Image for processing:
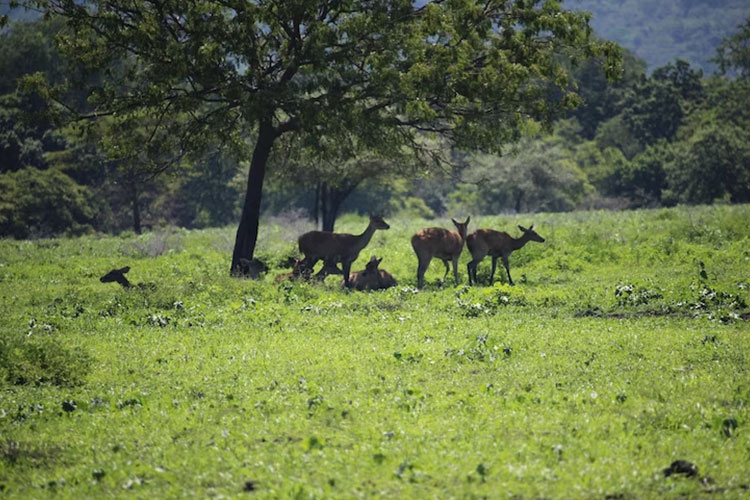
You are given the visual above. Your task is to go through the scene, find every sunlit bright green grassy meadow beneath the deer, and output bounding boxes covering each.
[0,205,750,499]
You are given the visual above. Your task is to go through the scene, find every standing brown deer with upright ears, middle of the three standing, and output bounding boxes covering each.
[411,217,471,288]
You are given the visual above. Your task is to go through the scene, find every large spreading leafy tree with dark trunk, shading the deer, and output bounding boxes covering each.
[20,0,619,272]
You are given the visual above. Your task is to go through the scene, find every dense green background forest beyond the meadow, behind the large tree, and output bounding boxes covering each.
[0,2,750,243]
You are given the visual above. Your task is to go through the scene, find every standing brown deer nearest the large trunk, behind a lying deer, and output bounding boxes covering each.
[297,215,391,285]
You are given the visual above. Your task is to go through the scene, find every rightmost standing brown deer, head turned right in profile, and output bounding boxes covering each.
[466,224,544,285]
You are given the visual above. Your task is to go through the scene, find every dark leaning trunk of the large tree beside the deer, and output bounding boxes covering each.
[230,121,277,276]
